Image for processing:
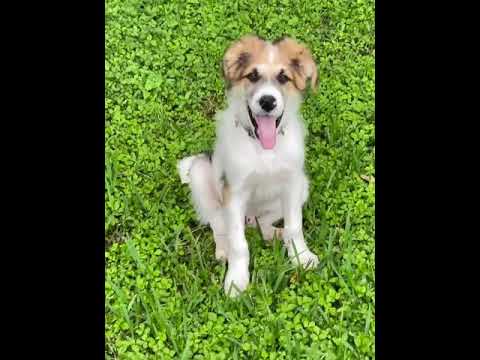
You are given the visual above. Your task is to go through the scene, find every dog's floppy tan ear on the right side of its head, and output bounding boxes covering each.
[275,38,317,90]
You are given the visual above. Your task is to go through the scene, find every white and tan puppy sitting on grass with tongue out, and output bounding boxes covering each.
[177,35,319,297]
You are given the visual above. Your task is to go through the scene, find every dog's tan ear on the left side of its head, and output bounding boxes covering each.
[223,35,265,82]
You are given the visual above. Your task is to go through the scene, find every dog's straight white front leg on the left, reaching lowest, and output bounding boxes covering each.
[224,191,250,297]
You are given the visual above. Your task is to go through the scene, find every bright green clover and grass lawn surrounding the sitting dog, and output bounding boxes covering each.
[105,0,375,360]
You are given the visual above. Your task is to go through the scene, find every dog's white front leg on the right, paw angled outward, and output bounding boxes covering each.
[282,176,318,268]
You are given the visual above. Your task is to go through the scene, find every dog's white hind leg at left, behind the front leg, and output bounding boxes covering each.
[177,154,228,260]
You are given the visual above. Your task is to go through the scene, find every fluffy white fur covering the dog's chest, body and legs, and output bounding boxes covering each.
[178,44,318,296]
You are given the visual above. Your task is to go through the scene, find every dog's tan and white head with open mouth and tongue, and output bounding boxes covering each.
[223,36,317,149]
